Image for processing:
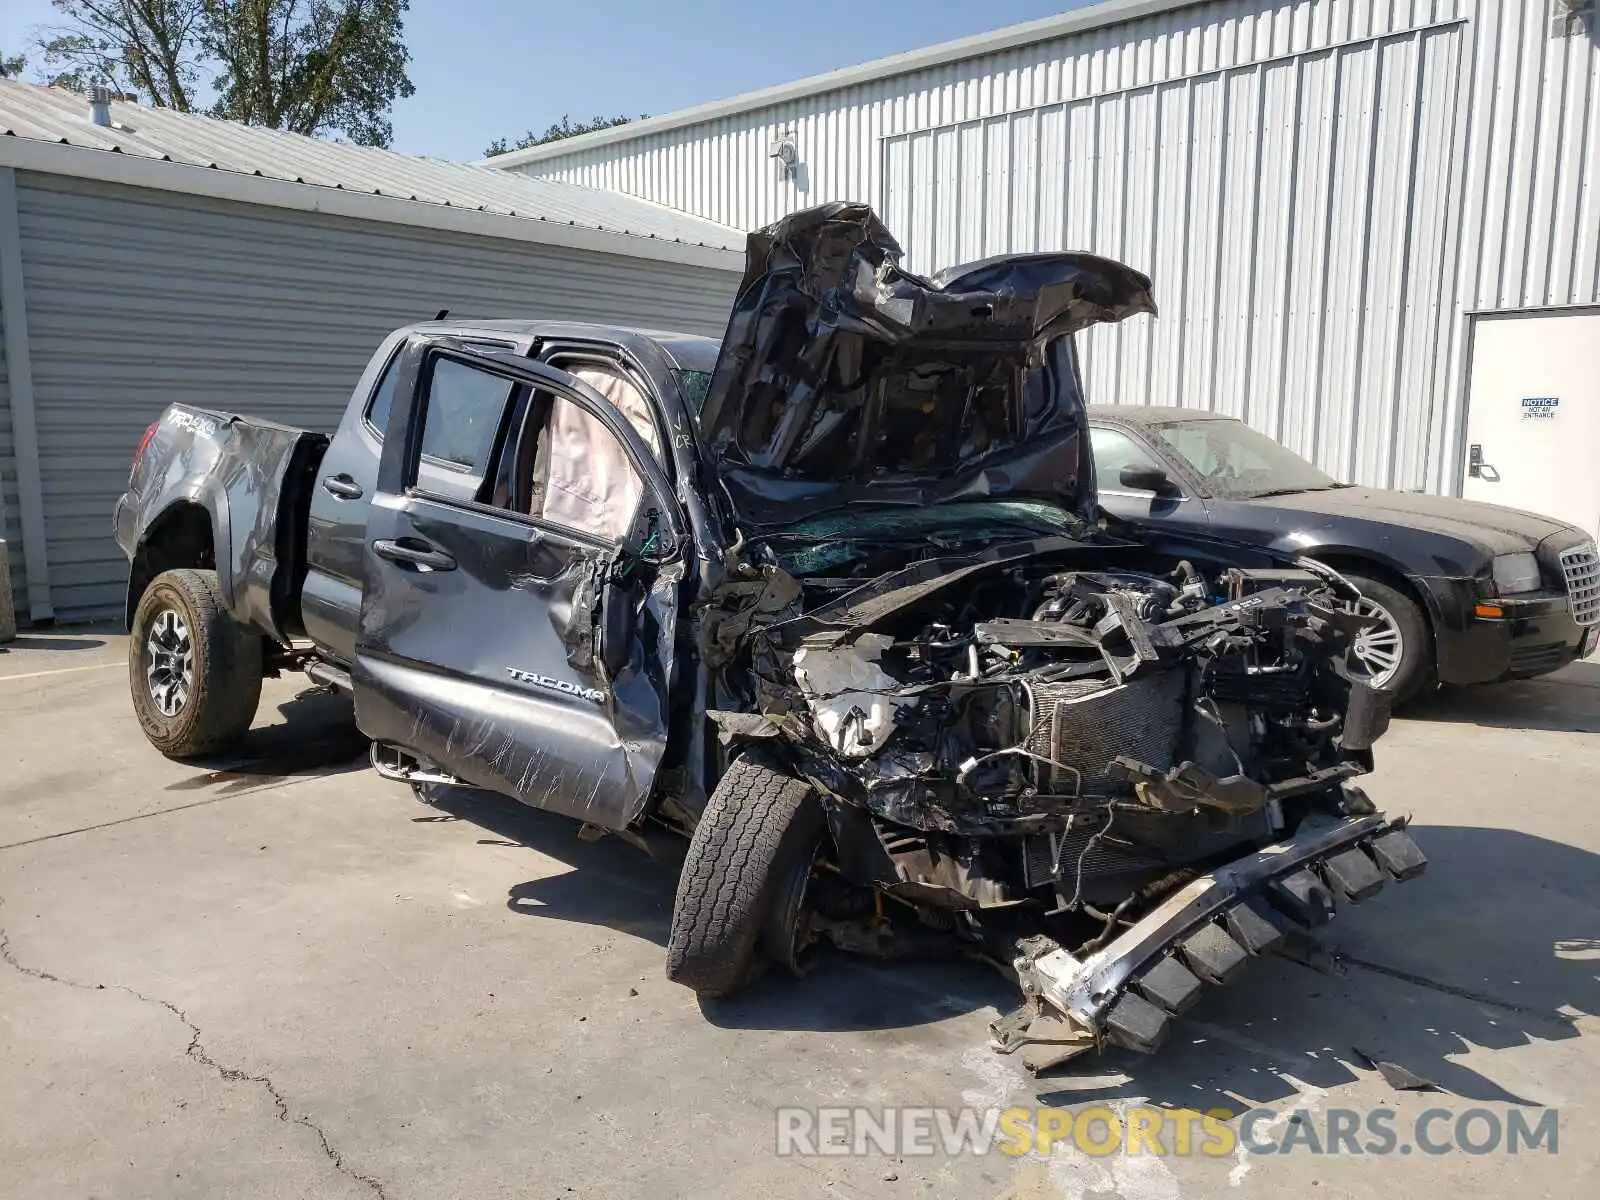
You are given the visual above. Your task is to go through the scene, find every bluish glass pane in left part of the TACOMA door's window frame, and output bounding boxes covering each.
[411,358,512,499]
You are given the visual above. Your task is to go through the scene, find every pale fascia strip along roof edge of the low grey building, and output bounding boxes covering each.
[0,134,744,272]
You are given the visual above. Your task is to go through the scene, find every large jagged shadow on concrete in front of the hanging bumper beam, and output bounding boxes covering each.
[1040,826,1600,1112]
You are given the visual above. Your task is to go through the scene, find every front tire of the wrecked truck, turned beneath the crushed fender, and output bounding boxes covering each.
[667,754,827,997]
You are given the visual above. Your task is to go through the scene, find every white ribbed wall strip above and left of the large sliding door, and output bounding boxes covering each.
[512,0,1465,229]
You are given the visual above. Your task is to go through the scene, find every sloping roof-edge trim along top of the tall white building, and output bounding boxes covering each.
[475,0,1205,171]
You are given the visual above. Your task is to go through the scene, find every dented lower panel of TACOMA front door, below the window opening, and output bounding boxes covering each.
[354,498,666,829]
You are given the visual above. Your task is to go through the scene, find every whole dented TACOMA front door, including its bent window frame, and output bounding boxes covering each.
[352,339,682,829]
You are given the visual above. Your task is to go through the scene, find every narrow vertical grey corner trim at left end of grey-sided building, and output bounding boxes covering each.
[0,166,56,624]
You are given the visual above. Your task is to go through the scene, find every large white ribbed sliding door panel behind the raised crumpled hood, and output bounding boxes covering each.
[883,22,1462,486]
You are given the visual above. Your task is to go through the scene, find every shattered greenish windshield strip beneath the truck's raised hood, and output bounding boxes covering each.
[766,501,1088,576]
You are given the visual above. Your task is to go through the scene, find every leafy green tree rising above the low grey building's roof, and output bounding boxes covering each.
[38,0,416,146]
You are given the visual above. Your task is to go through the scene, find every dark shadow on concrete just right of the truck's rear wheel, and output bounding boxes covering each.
[166,693,368,795]
